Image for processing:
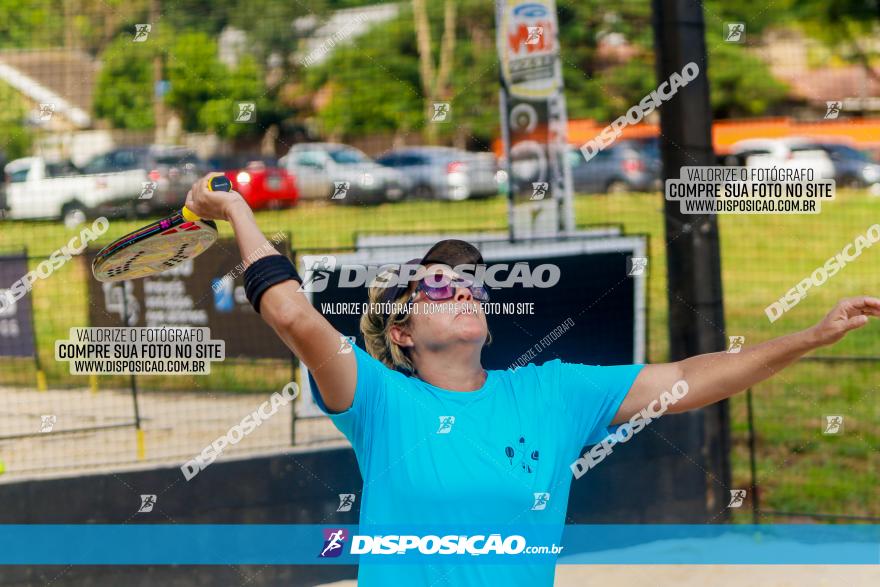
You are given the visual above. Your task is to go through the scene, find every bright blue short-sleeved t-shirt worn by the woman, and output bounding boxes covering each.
[312,345,642,587]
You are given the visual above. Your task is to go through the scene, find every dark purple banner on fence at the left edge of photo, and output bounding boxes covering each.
[0,255,36,357]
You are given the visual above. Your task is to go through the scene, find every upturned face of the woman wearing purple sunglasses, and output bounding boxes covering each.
[392,265,489,352]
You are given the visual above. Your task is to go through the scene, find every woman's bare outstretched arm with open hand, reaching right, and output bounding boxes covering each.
[613,296,880,424]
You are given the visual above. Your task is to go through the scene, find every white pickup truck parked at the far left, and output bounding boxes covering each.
[5,157,149,226]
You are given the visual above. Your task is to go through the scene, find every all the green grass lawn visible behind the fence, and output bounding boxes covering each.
[0,191,880,517]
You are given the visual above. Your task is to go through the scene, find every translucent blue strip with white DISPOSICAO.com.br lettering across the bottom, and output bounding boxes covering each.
[0,522,880,567]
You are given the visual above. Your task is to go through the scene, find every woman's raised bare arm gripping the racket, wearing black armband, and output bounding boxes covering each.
[186,173,357,412]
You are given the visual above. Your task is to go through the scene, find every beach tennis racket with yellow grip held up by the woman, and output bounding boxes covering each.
[92,175,232,282]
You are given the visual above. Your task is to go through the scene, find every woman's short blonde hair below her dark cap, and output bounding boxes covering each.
[360,270,492,375]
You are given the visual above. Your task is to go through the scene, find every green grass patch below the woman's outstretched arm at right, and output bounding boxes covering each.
[731,362,880,521]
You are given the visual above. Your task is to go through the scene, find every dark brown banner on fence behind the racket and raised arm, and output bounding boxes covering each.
[86,239,291,359]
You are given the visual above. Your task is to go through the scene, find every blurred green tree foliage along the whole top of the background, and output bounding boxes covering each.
[10,0,880,142]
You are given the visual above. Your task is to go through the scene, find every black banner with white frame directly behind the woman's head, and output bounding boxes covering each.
[297,234,647,417]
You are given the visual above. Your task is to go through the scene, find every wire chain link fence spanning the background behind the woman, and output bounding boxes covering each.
[0,0,880,522]
